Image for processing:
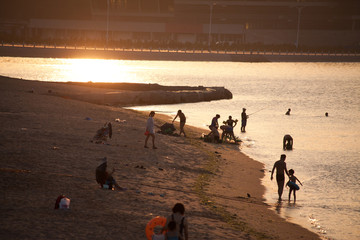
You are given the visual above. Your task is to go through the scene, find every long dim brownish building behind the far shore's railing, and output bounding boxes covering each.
[0,0,360,48]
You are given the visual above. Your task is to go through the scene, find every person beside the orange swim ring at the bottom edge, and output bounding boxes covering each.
[161,203,189,240]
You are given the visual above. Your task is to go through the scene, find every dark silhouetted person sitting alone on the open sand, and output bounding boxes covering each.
[95,157,126,191]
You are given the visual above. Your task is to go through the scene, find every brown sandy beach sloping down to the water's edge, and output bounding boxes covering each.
[0,77,320,239]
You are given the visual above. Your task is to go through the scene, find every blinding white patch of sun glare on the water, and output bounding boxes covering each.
[61,59,141,82]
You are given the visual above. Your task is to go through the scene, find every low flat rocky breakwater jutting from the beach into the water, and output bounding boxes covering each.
[58,83,232,106]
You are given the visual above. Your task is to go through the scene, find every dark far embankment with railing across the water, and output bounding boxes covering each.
[0,46,360,62]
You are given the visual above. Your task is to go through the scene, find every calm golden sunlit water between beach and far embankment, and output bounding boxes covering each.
[0,58,360,240]
